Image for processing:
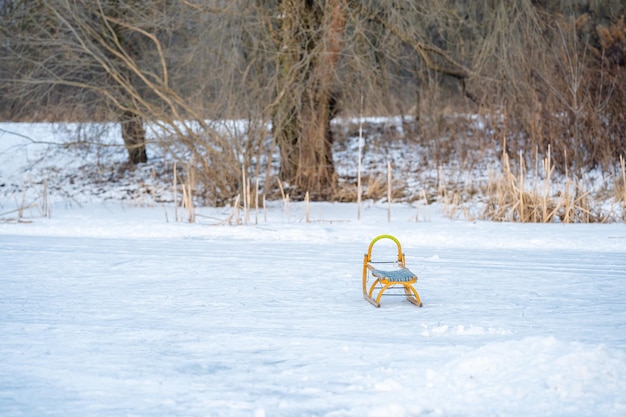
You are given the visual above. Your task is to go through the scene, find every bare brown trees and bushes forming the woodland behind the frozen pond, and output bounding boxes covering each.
[0,0,626,222]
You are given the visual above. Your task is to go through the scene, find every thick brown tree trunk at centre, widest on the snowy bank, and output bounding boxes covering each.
[272,0,345,198]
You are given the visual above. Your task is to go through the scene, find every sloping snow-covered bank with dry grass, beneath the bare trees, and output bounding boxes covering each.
[0,119,626,223]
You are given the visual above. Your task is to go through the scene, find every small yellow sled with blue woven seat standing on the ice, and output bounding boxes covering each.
[363,235,422,307]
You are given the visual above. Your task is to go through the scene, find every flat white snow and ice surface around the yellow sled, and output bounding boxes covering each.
[0,125,626,417]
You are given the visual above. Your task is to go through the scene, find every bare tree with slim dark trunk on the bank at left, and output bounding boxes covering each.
[1,0,155,164]
